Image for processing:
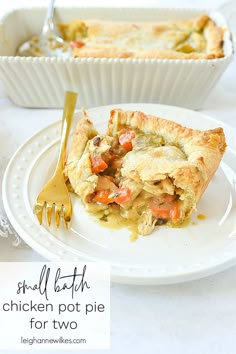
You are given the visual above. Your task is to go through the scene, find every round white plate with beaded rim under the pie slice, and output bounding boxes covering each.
[3,104,236,284]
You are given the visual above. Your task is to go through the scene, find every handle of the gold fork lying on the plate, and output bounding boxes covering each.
[55,91,77,174]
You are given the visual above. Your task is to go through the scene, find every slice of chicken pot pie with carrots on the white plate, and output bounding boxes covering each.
[66,109,226,235]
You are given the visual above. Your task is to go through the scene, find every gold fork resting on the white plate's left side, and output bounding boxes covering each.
[34,92,77,228]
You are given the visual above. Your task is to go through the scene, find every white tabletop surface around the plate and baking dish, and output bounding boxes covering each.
[0,0,236,354]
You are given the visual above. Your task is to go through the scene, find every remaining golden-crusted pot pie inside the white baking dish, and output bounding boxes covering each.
[59,15,224,59]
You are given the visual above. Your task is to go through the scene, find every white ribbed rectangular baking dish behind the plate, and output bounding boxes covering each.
[0,8,233,109]
